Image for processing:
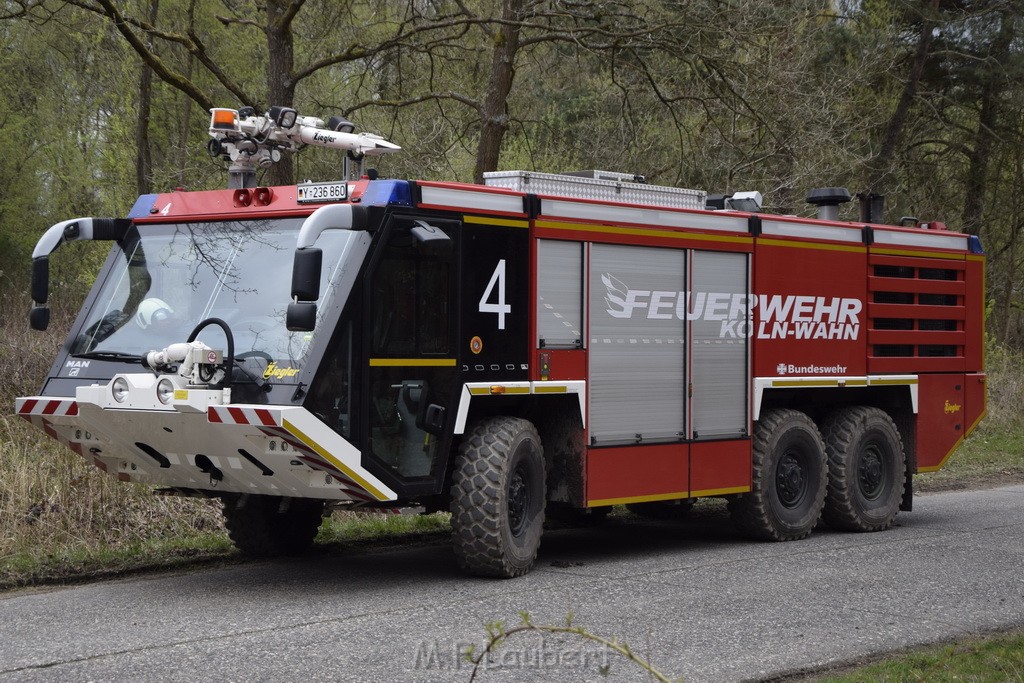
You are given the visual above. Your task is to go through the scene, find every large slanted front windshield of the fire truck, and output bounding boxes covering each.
[72,218,355,381]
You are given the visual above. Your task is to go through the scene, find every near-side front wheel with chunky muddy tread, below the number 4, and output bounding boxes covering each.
[451,417,545,579]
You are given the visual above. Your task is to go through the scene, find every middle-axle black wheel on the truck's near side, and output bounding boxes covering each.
[729,410,827,541]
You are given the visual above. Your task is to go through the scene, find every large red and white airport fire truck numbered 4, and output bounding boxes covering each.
[16,108,985,578]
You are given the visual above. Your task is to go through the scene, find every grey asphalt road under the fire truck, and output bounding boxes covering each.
[0,486,1024,683]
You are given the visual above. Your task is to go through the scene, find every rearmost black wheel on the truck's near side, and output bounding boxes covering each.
[821,405,906,531]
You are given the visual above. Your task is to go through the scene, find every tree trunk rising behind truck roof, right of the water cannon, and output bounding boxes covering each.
[473,0,523,183]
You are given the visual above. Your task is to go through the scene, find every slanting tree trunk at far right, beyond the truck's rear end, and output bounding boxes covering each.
[961,10,1016,234]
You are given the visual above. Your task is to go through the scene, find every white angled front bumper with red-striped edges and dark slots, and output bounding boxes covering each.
[15,374,396,503]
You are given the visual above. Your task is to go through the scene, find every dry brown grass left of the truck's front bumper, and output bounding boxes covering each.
[0,283,228,583]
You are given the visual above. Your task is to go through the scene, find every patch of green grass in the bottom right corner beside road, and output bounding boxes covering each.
[806,631,1024,683]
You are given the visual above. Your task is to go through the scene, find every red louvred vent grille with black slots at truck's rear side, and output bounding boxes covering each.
[867,255,967,373]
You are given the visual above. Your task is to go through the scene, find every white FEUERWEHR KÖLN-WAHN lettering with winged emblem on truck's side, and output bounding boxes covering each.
[601,272,864,339]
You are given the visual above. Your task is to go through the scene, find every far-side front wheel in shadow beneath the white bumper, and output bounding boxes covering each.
[224,495,324,557]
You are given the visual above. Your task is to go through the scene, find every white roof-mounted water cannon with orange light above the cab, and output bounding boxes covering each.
[207,106,401,189]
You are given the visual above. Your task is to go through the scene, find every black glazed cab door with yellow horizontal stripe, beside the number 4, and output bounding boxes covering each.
[364,216,459,496]
